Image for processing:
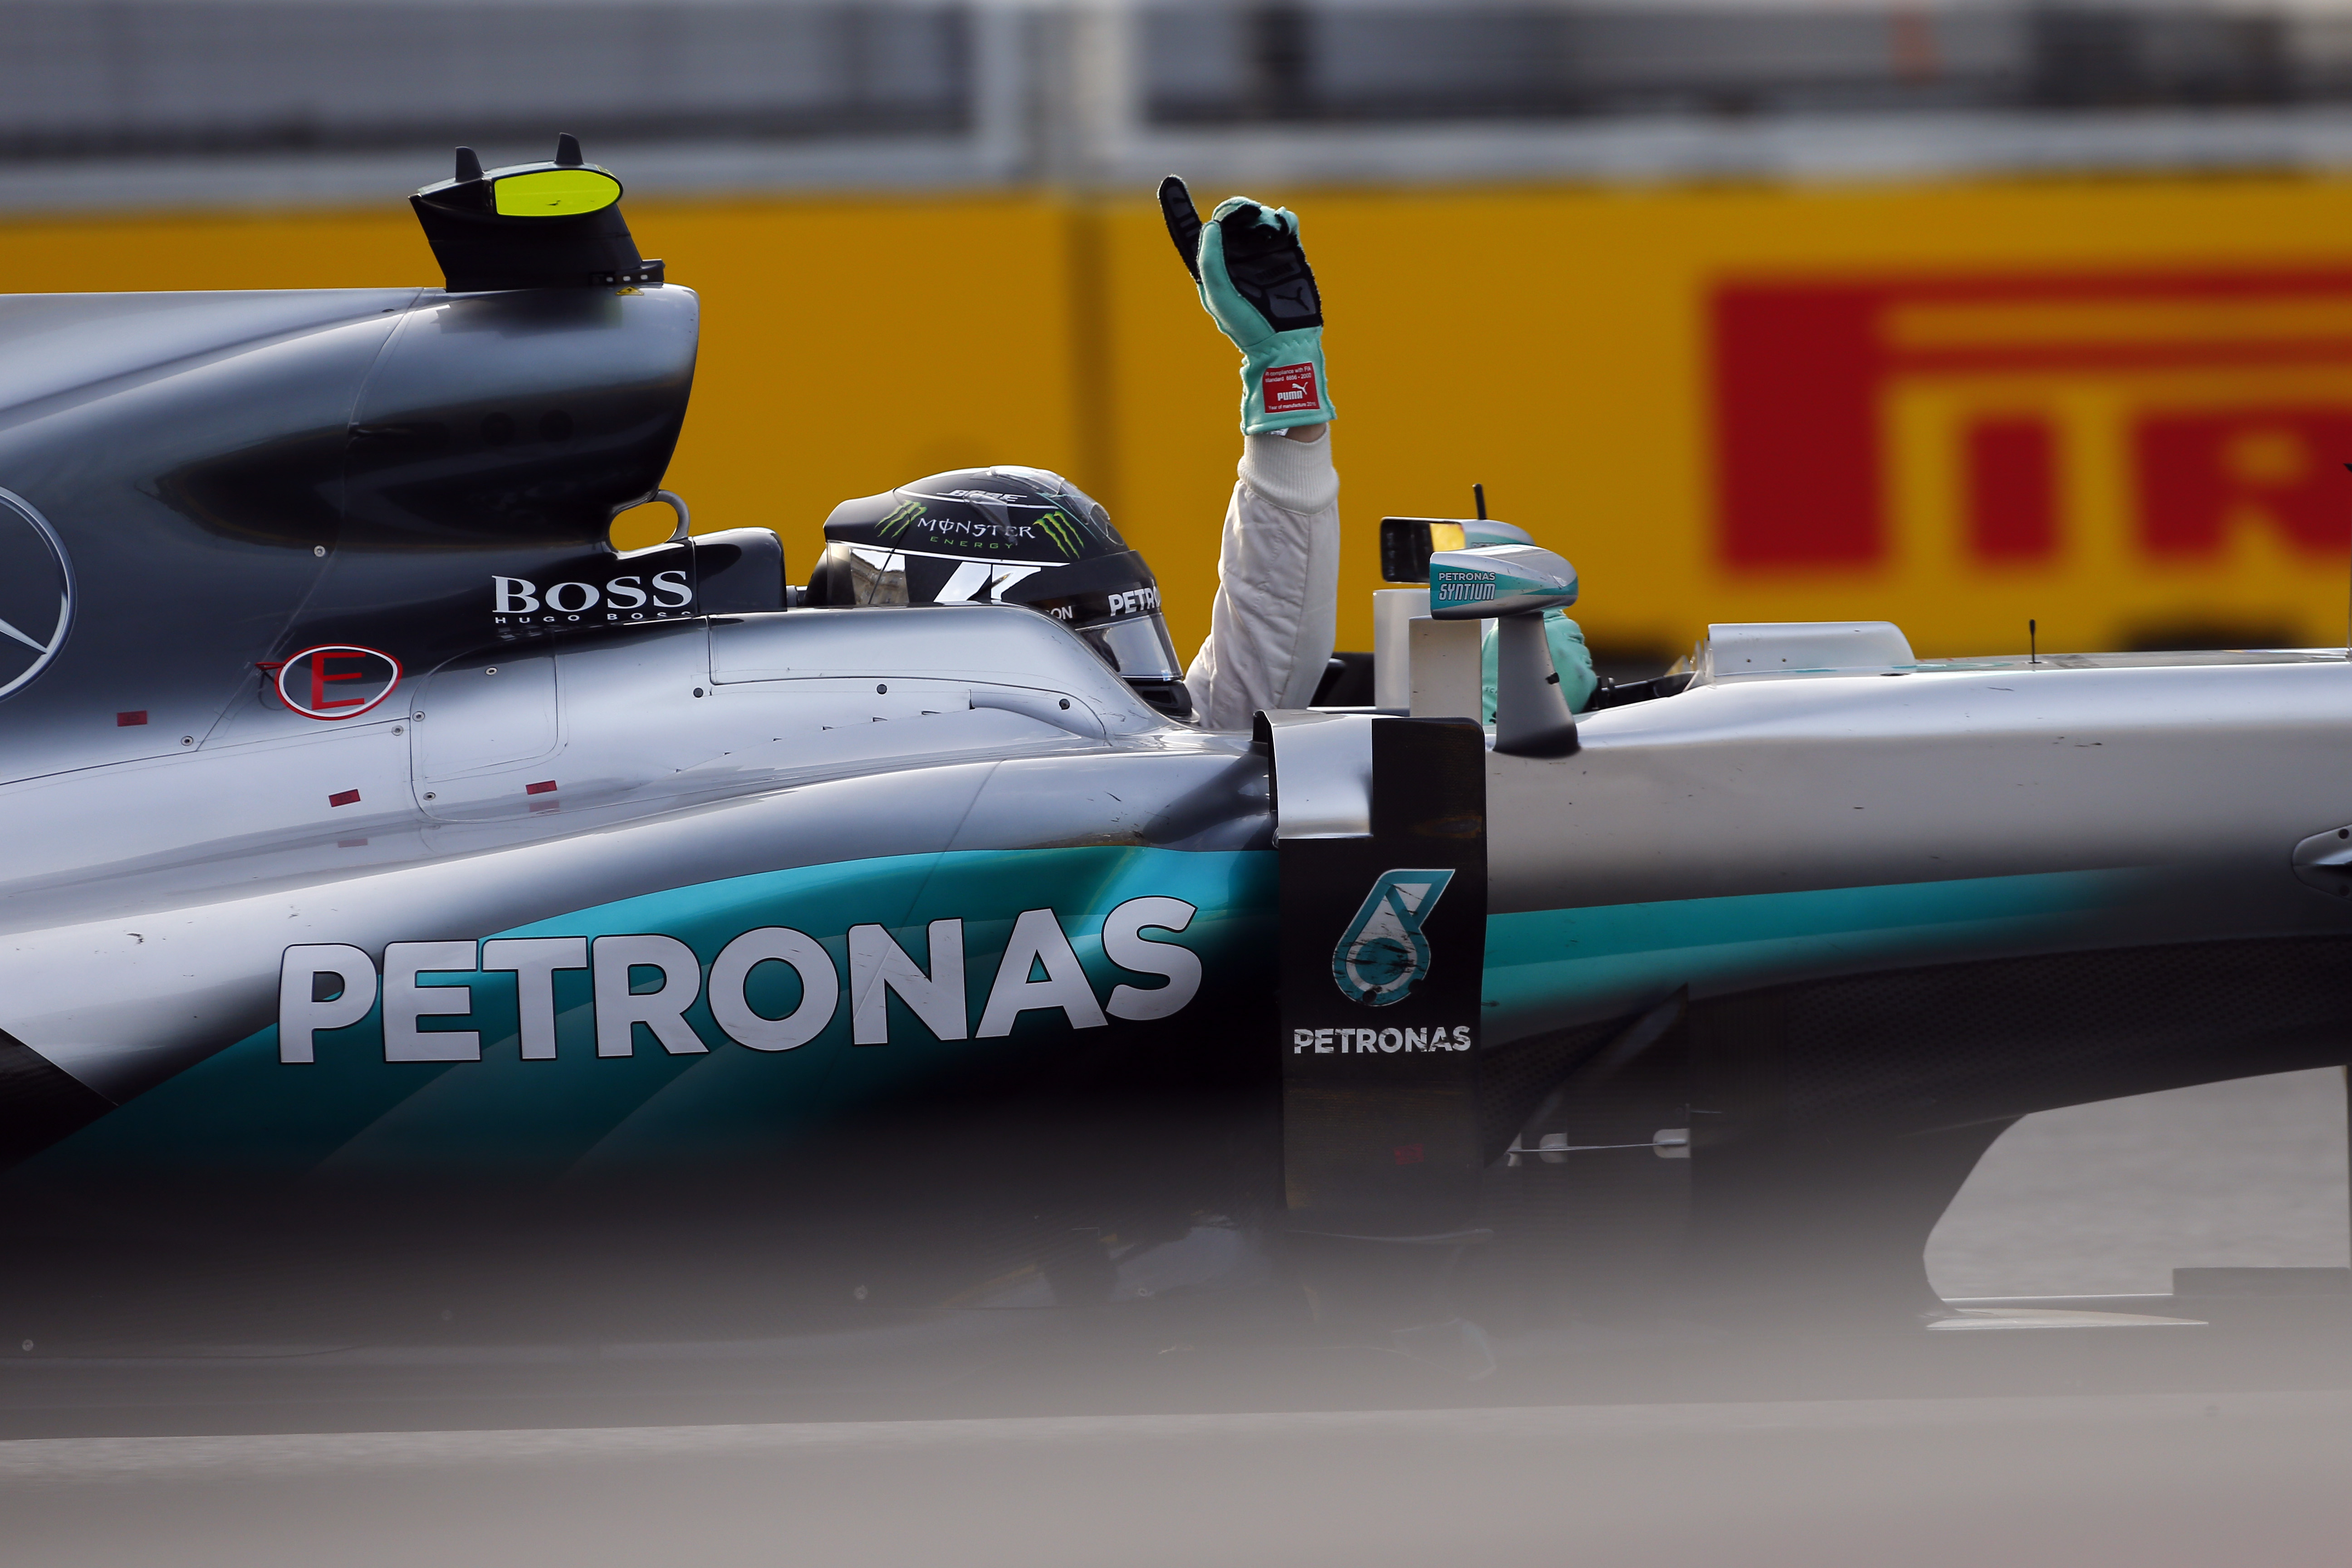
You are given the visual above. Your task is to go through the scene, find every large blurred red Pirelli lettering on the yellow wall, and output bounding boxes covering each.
[1712,268,2352,569]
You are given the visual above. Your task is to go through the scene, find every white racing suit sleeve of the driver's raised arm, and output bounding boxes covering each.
[1183,426,1338,729]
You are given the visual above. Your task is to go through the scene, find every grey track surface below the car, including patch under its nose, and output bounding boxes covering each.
[0,1074,2352,1568]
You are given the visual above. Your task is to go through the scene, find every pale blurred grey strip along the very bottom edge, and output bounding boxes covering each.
[14,1394,2352,1568]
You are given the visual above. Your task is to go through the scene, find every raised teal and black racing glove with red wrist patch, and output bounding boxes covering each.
[1160,174,1331,435]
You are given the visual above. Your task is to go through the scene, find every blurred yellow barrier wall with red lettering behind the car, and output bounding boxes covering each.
[14,179,2352,653]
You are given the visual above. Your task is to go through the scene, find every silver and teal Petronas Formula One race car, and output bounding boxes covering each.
[0,141,2352,1359]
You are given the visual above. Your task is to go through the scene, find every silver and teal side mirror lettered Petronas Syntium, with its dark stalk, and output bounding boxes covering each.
[1430,545,1576,757]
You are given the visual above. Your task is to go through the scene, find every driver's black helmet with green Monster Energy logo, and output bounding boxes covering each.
[807,468,1192,720]
